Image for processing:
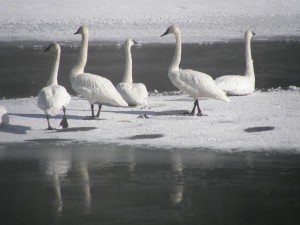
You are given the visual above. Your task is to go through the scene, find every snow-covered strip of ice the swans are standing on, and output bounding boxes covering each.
[0,89,300,151]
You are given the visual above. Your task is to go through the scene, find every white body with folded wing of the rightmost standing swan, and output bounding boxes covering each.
[173,69,225,99]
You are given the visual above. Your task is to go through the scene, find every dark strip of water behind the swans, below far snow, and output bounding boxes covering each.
[0,41,300,98]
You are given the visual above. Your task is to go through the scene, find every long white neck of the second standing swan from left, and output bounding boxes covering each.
[71,30,89,75]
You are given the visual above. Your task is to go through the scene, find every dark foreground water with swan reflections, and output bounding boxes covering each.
[0,143,300,225]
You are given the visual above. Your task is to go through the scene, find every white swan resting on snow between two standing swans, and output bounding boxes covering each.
[116,39,148,106]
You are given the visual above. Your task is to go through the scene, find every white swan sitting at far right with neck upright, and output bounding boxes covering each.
[215,30,255,95]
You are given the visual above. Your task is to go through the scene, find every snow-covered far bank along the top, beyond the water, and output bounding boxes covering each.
[0,0,300,43]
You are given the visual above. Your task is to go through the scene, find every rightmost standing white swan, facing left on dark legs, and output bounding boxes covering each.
[161,25,230,116]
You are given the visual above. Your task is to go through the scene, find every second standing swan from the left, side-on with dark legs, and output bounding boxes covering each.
[70,26,128,119]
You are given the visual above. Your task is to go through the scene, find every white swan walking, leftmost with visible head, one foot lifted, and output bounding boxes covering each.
[37,42,71,130]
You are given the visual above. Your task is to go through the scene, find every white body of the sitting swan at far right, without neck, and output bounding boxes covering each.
[215,75,254,95]
